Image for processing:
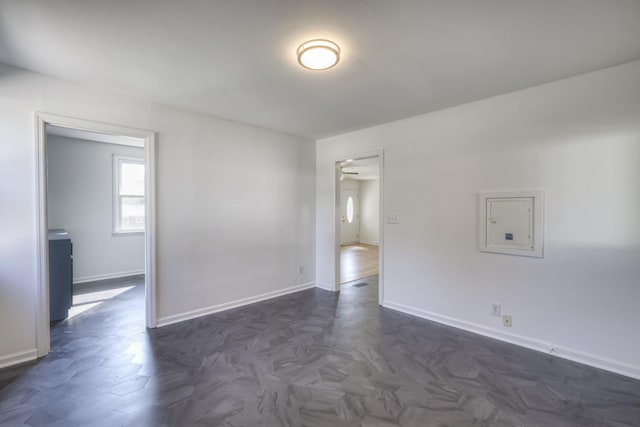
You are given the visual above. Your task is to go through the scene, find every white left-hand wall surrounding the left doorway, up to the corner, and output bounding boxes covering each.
[0,65,315,365]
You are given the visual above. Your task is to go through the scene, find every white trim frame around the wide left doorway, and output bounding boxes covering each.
[35,112,157,357]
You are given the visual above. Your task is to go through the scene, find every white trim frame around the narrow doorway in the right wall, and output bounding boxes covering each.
[333,150,385,305]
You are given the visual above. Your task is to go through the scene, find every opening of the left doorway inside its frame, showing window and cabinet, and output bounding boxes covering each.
[46,126,145,332]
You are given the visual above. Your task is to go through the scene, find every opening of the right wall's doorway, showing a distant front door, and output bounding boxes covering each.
[336,155,381,298]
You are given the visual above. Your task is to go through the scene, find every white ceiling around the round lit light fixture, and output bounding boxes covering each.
[0,0,640,139]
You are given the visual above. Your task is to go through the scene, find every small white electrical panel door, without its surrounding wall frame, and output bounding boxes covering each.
[487,197,533,249]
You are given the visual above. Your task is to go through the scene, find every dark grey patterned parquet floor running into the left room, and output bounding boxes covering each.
[0,277,640,427]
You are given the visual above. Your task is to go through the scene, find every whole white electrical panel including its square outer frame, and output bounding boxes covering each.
[478,191,544,258]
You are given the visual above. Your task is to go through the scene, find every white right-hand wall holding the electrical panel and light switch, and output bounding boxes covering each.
[316,62,640,377]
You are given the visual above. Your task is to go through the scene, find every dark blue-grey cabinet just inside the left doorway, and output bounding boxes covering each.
[49,229,73,322]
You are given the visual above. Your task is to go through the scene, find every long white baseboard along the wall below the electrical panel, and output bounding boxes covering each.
[382,301,640,379]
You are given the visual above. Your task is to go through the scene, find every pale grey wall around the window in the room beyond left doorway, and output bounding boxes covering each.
[47,135,144,282]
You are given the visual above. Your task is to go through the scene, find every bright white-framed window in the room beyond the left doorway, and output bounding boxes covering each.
[113,155,144,233]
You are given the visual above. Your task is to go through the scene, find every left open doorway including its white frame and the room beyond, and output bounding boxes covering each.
[37,114,155,356]
